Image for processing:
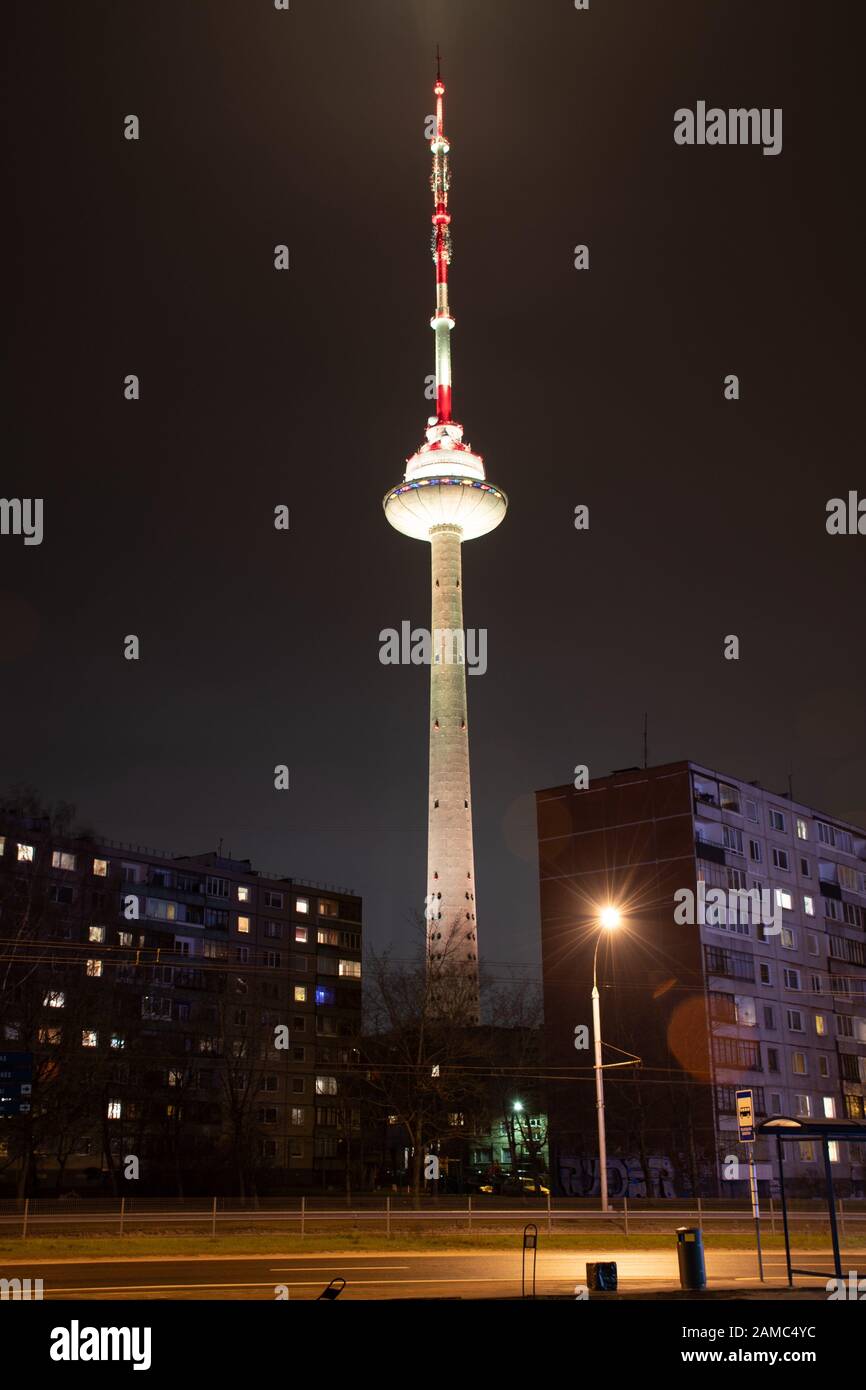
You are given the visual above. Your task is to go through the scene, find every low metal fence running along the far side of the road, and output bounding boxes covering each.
[0,1194,866,1240]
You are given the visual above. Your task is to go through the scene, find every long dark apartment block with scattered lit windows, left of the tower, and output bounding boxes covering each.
[0,816,363,1194]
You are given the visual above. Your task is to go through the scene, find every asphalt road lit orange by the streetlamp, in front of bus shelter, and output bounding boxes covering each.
[0,1248,863,1300]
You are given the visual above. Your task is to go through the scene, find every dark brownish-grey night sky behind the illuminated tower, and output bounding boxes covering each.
[0,0,866,967]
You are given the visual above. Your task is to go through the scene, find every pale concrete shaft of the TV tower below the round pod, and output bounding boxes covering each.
[427,525,478,1017]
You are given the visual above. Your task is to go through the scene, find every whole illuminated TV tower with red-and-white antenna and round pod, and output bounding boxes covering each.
[384,62,507,1023]
